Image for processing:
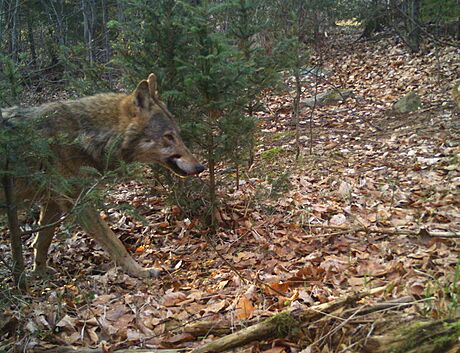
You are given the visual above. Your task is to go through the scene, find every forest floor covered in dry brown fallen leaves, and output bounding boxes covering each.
[0,28,460,353]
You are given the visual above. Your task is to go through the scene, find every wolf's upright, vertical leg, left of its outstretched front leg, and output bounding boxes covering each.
[32,202,61,276]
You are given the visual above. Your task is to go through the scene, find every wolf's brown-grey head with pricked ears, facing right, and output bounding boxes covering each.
[122,74,204,177]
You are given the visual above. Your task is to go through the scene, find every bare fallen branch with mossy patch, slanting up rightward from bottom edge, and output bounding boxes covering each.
[192,287,385,353]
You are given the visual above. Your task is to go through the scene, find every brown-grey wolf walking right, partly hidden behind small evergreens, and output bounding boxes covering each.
[0,74,205,278]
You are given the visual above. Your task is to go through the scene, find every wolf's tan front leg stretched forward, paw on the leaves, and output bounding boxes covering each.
[79,207,162,278]
